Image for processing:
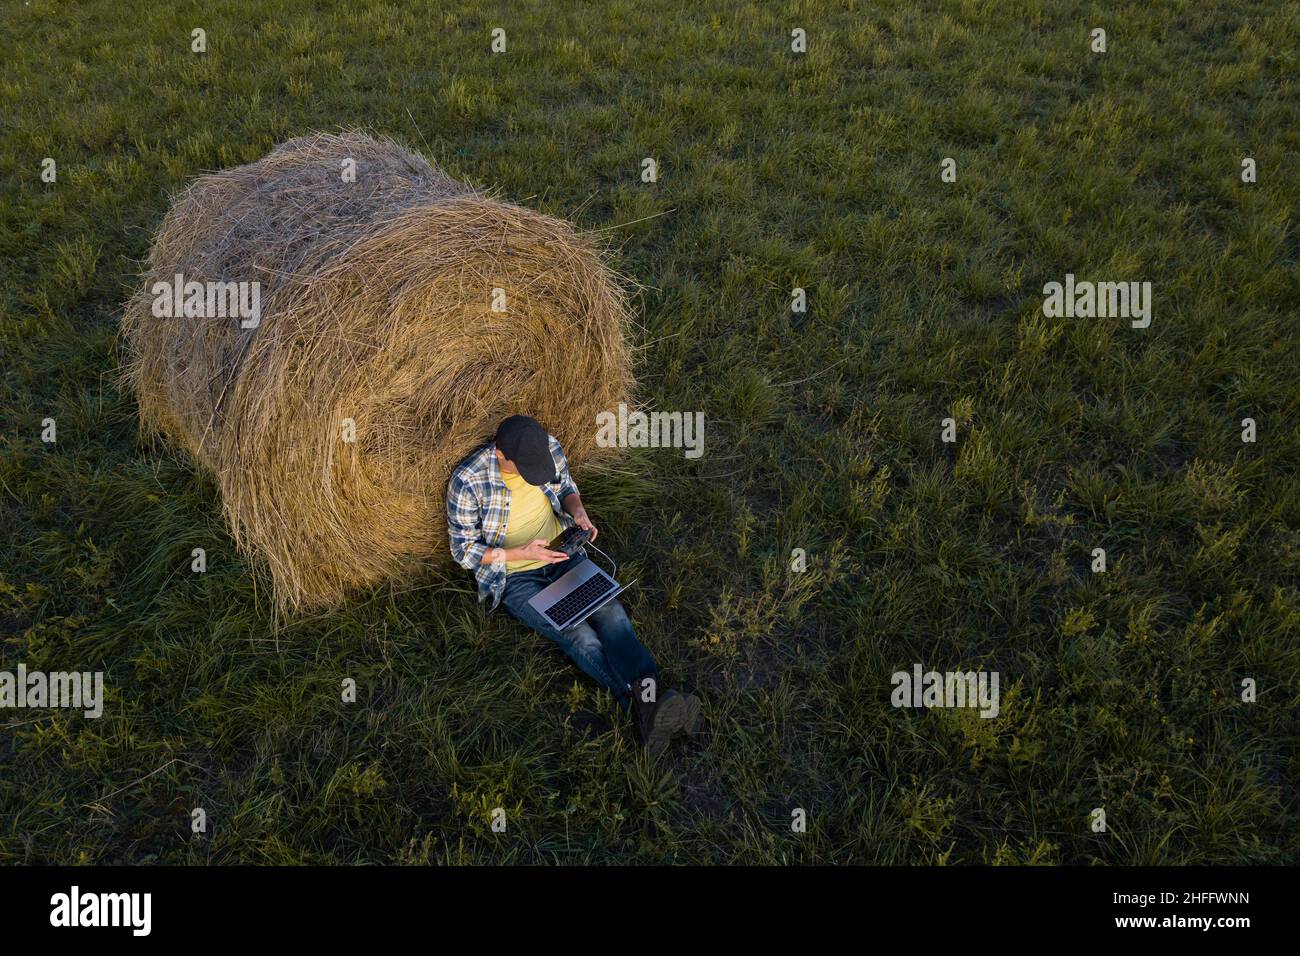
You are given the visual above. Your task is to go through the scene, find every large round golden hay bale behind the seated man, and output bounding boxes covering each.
[124,134,632,610]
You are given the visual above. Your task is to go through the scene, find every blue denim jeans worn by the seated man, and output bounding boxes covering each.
[501,555,659,706]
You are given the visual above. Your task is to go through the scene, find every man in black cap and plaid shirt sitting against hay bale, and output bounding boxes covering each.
[447,415,699,754]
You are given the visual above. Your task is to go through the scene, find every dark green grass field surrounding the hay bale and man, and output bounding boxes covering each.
[0,0,1300,864]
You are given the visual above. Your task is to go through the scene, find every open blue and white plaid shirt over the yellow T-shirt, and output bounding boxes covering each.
[447,436,577,610]
